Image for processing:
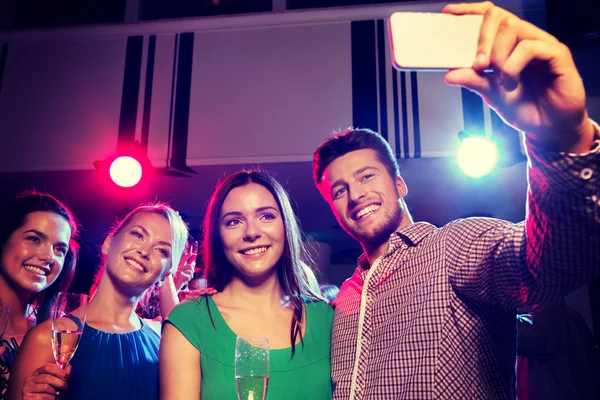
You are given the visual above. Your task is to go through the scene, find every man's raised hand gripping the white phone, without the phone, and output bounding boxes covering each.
[443,2,594,153]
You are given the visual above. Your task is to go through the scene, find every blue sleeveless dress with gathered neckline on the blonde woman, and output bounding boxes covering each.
[61,320,160,400]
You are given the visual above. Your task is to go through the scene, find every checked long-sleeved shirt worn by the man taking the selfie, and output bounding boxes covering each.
[331,124,600,400]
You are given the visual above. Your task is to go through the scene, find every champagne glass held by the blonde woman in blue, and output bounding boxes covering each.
[52,293,89,369]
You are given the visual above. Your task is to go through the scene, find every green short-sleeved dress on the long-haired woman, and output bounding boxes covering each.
[166,296,333,400]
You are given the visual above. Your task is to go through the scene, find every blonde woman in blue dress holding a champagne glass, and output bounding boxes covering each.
[8,204,188,400]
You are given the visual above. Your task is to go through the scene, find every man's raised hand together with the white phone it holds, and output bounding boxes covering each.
[389,2,594,153]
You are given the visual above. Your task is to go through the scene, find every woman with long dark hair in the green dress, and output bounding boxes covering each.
[160,171,333,400]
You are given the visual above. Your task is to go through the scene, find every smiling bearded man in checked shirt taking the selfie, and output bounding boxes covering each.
[313,2,600,400]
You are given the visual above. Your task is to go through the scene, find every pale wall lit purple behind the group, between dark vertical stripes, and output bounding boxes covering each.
[0,0,544,172]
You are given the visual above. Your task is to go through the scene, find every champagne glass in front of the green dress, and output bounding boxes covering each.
[235,336,269,400]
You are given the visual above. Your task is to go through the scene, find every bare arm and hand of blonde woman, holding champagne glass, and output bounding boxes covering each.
[7,321,71,400]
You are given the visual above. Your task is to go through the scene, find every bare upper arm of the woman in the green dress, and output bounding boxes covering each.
[158,322,202,400]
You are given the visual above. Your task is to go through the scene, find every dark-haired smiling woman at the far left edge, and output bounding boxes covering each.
[0,192,78,399]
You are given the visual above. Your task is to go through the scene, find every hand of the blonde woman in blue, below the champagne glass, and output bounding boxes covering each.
[23,363,71,400]
